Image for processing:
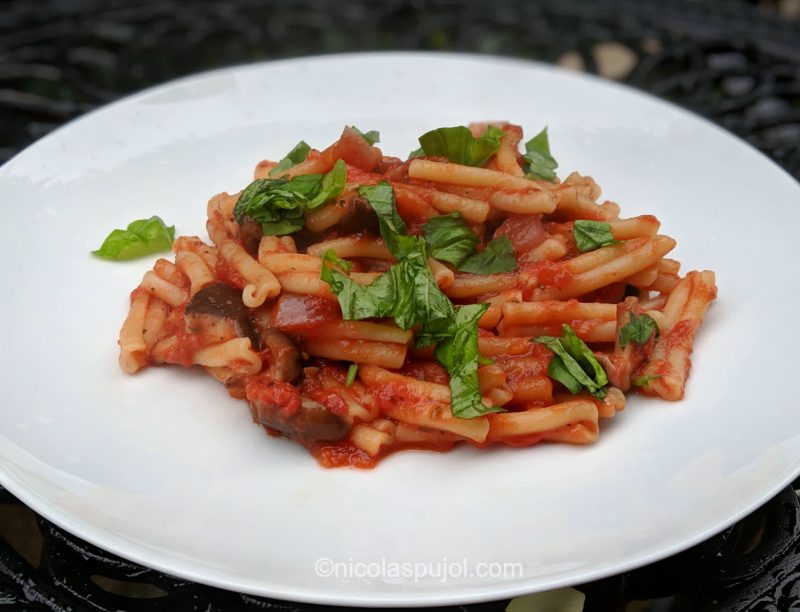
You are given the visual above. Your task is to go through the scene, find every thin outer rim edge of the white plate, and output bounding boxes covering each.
[0,51,800,607]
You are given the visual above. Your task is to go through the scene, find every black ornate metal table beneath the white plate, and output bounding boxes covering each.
[0,0,800,612]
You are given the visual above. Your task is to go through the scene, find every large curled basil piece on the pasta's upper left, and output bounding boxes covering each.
[233,159,347,236]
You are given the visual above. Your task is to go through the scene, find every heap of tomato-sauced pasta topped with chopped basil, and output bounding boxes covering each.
[119,123,717,468]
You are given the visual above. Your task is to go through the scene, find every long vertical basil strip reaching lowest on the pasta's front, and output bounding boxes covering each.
[435,304,504,419]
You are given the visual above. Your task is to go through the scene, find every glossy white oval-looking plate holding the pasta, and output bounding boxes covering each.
[0,53,800,605]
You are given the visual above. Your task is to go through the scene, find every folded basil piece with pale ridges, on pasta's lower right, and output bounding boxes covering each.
[532,323,608,399]
